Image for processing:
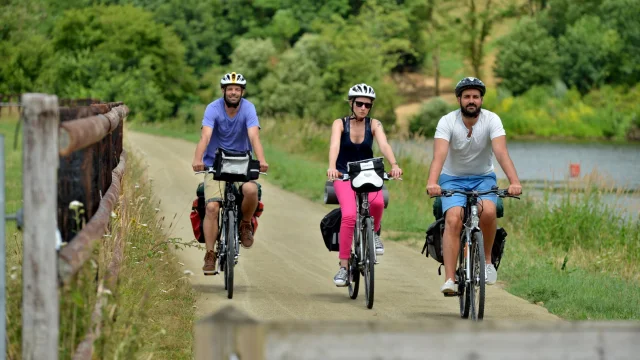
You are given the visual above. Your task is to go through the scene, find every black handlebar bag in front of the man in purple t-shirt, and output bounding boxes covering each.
[213,149,260,182]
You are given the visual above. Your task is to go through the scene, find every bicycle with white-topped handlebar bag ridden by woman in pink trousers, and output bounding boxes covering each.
[338,158,402,309]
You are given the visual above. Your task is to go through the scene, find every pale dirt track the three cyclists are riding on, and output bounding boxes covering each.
[125,132,558,321]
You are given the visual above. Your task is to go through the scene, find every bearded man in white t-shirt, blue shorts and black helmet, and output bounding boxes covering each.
[427,77,522,294]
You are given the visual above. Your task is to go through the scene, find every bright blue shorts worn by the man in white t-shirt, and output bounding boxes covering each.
[438,173,498,213]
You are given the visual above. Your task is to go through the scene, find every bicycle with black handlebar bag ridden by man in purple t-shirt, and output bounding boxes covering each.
[196,148,267,299]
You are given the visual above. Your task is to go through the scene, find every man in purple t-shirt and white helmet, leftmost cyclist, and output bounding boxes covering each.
[193,72,269,275]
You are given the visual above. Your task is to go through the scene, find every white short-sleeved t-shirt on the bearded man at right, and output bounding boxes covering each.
[435,109,506,176]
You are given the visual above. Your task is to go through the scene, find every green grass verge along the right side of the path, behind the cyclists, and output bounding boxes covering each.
[134,115,640,320]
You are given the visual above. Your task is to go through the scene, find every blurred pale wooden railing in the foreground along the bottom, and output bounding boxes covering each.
[195,306,640,360]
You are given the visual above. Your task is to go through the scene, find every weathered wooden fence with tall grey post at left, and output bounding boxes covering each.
[20,94,129,359]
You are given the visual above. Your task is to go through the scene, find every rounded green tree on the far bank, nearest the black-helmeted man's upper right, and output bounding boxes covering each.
[494,18,560,95]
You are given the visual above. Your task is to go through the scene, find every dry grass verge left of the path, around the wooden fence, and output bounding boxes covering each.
[0,114,195,359]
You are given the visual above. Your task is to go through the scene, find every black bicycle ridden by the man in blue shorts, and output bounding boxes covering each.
[431,186,520,321]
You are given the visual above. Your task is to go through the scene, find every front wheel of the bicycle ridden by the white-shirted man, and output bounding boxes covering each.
[469,231,486,321]
